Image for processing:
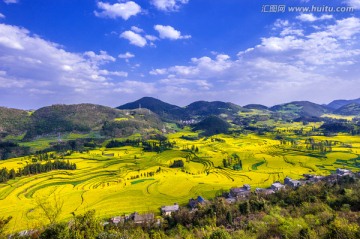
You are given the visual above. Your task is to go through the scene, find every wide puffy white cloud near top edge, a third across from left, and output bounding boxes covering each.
[94,1,141,20]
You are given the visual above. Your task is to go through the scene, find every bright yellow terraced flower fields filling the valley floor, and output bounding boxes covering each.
[0,131,360,231]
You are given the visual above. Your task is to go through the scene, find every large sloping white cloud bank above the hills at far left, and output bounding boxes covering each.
[0,24,127,107]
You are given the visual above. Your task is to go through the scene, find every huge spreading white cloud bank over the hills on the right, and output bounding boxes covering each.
[149,17,360,105]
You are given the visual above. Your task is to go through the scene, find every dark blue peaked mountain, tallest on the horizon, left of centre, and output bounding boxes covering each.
[117,97,188,121]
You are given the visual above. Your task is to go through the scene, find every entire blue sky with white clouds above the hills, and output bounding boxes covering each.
[0,0,360,109]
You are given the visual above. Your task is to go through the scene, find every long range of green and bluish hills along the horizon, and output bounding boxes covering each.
[0,97,360,139]
